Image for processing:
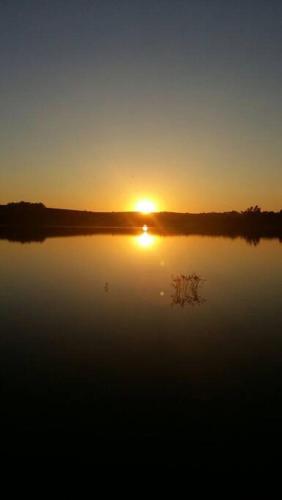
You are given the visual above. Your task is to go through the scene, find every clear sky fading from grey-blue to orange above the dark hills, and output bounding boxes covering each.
[0,0,282,212]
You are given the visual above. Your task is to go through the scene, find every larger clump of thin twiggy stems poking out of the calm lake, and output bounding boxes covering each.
[171,274,206,307]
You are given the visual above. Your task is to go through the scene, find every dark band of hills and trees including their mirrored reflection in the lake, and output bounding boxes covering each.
[0,202,282,244]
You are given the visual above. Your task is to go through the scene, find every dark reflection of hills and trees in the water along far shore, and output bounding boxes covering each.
[0,225,282,246]
